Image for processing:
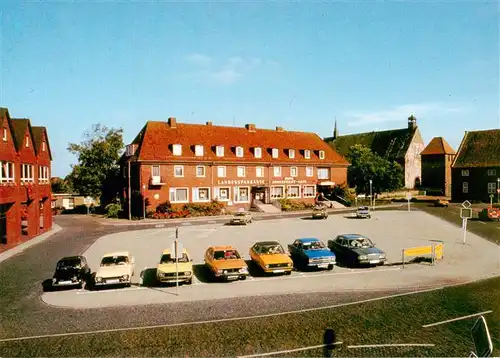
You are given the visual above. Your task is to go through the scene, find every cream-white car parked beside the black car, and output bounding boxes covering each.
[95,251,135,287]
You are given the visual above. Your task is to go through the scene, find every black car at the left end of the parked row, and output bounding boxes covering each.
[52,256,91,288]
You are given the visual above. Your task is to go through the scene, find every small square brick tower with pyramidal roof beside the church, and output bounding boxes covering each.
[420,137,456,196]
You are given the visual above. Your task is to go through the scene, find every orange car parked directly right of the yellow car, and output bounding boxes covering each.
[205,246,248,281]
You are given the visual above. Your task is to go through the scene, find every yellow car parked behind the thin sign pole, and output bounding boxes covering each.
[156,249,193,285]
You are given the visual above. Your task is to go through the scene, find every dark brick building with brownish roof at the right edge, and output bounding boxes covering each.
[451,129,500,202]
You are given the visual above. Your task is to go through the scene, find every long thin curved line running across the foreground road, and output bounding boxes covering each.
[0,275,500,343]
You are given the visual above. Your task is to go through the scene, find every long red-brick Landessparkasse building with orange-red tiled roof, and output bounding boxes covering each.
[121,118,349,216]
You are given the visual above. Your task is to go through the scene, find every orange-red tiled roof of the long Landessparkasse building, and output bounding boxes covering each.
[127,118,349,166]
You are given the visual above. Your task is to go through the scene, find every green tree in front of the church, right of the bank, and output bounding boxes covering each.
[347,144,404,194]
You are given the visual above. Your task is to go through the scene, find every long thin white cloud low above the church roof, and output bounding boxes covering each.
[345,102,462,127]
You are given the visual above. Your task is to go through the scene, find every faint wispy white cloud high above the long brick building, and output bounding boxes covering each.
[186,54,278,85]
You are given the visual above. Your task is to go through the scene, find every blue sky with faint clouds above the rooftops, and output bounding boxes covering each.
[0,1,500,176]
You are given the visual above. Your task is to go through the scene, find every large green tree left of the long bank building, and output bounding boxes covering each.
[68,124,124,204]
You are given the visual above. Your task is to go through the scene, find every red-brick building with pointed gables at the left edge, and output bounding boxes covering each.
[0,108,52,251]
